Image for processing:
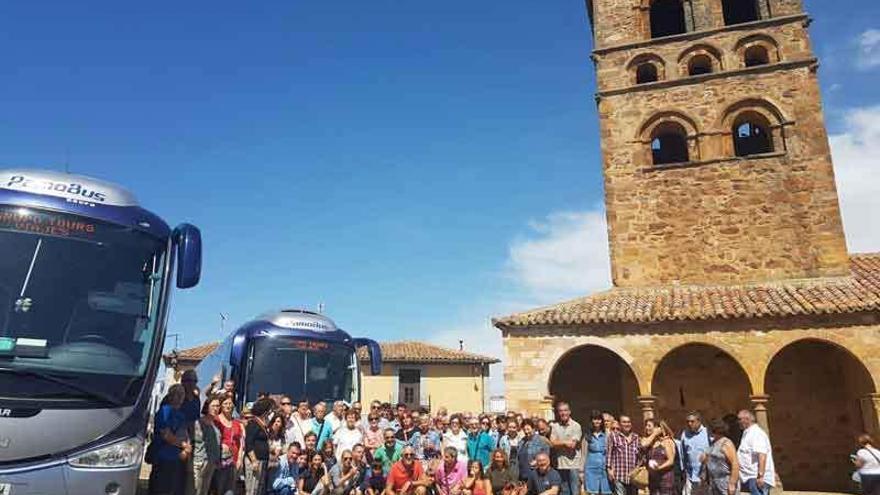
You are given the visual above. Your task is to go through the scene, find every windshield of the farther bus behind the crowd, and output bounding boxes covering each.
[245,336,357,403]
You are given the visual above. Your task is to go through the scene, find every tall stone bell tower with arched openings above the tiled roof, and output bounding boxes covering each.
[588,0,849,287]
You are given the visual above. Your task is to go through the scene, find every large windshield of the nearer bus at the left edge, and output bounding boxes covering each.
[0,205,166,404]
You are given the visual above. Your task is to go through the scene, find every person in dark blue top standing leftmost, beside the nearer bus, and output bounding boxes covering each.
[150,383,192,495]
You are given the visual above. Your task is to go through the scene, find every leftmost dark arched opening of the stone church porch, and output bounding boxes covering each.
[545,343,641,424]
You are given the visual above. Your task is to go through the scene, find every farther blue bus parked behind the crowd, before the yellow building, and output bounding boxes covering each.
[197,310,382,407]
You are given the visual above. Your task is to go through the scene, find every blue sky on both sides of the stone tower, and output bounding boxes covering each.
[0,0,880,392]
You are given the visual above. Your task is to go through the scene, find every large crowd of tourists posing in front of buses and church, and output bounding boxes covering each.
[146,371,880,495]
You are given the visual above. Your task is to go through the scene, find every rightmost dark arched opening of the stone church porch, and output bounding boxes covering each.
[764,337,877,492]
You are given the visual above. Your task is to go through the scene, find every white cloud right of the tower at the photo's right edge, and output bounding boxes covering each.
[830,104,880,252]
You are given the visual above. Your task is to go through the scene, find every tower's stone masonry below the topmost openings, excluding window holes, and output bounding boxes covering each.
[597,16,848,286]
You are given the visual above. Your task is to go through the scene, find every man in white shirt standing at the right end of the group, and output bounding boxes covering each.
[736,409,776,495]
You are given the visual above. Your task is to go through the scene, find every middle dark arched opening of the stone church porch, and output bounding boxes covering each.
[651,342,753,436]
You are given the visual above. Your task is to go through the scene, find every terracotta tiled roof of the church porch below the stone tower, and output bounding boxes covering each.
[493,253,880,328]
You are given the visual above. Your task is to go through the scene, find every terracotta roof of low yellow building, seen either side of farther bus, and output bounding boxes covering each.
[165,341,499,364]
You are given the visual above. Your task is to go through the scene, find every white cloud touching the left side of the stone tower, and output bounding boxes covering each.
[508,209,611,302]
